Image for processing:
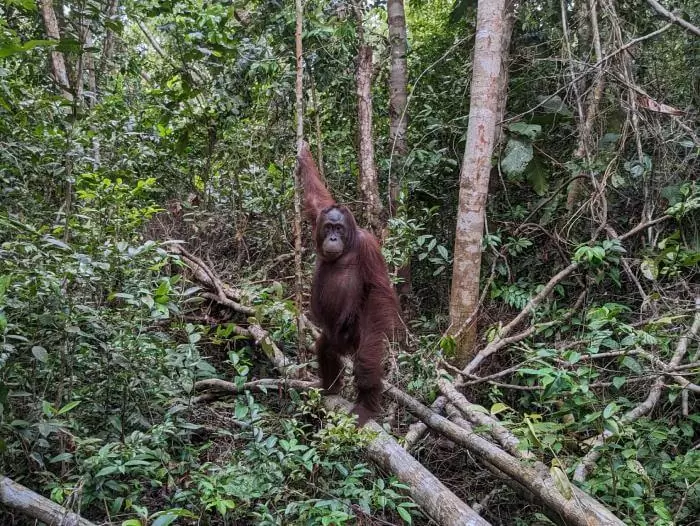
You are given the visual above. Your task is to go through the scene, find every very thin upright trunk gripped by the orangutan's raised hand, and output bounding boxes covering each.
[294,0,306,359]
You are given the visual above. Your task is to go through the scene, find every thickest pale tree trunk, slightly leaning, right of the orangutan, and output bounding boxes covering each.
[450,0,512,366]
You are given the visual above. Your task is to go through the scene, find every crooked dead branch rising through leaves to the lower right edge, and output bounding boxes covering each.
[574,308,700,482]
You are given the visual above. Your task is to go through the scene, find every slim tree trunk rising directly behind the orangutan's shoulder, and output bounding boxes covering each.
[353,4,382,234]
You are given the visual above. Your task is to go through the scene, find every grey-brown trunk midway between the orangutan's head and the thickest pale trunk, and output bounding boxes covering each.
[386,0,411,303]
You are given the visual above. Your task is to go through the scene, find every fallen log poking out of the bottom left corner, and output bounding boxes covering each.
[0,475,95,526]
